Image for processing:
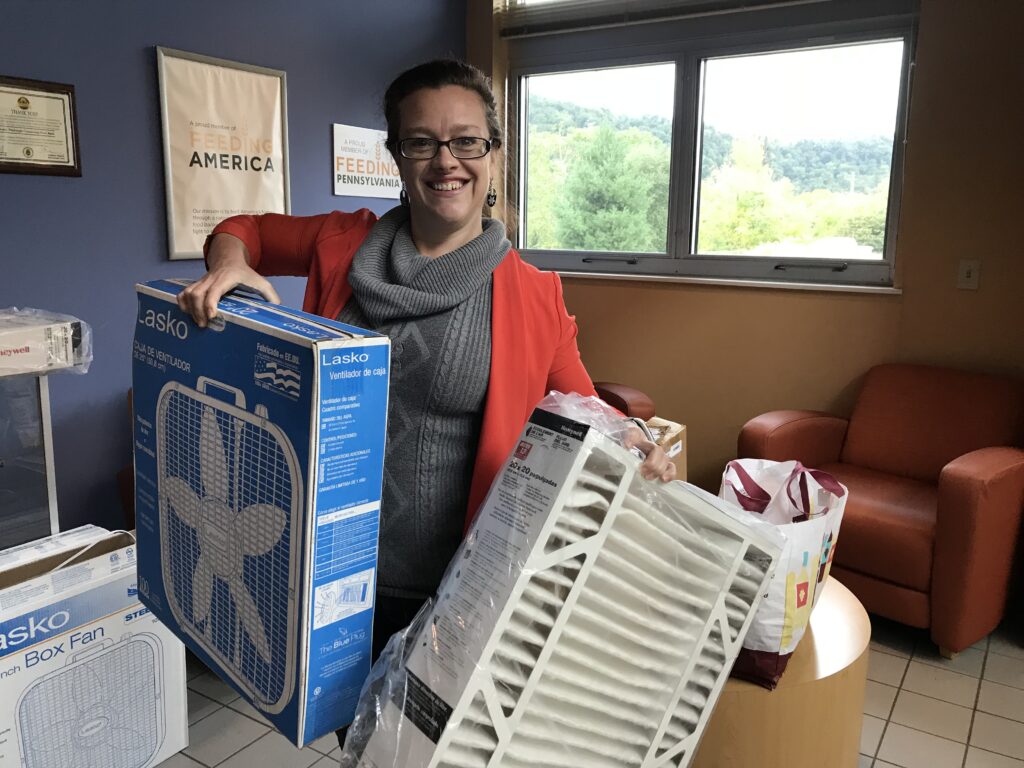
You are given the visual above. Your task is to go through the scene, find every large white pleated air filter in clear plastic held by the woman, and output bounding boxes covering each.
[341,393,783,768]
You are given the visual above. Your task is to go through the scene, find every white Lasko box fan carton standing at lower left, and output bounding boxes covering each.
[0,526,188,768]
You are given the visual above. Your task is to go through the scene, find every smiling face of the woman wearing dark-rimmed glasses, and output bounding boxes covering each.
[398,85,494,241]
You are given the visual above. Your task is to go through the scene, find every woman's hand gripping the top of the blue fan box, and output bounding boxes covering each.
[178,232,281,328]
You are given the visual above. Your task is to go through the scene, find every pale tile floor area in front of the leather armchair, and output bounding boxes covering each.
[860,616,1024,768]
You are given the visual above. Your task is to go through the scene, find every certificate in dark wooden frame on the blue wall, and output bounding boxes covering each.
[0,75,82,176]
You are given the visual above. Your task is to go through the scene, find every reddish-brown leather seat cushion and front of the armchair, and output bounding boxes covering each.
[820,464,938,592]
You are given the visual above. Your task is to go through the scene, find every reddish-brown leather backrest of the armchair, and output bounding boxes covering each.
[840,365,1024,482]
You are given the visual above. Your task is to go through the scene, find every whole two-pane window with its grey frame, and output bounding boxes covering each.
[509,0,915,286]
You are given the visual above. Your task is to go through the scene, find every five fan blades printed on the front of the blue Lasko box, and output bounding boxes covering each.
[164,408,288,662]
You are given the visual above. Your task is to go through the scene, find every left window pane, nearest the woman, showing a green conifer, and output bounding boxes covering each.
[522,63,676,254]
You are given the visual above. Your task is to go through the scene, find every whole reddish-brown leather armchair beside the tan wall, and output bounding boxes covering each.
[738,365,1024,656]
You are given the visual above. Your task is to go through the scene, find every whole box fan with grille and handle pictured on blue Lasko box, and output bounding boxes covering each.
[157,379,302,713]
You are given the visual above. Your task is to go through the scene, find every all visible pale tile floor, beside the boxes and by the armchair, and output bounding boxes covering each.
[161,616,1024,768]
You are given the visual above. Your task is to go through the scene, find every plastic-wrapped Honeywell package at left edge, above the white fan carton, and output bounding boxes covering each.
[0,307,92,376]
